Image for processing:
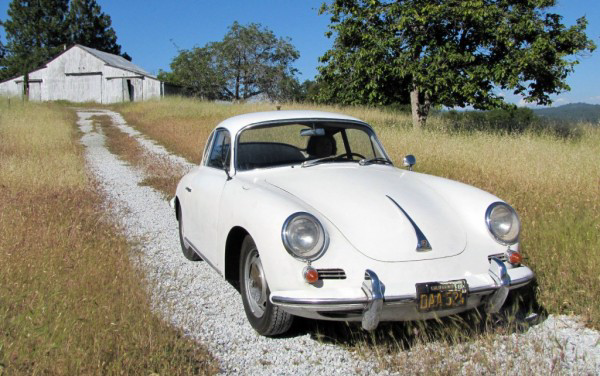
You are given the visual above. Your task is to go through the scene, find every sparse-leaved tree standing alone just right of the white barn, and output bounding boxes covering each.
[162,22,299,100]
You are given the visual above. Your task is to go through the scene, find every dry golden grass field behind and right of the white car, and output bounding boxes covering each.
[115,98,600,329]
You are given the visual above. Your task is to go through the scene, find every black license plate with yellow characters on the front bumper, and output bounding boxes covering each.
[416,279,469,312]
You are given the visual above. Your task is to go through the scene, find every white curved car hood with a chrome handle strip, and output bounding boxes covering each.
[265,164,467,262]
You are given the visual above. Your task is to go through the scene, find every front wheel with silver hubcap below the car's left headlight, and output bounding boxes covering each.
[239,235,294,336]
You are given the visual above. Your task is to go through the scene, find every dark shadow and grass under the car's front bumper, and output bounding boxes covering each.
[285,281,547,350]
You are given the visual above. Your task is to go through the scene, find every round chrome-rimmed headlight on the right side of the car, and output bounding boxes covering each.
[485,202,521,245]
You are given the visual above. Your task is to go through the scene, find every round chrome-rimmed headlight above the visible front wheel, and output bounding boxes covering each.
[281,213,328,261]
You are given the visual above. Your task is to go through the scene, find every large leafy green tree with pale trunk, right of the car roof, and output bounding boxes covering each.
[318,0,595,127]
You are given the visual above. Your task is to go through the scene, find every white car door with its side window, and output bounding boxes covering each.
[186,129,231,270]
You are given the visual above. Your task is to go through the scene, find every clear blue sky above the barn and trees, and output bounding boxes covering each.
[0,0,600,105]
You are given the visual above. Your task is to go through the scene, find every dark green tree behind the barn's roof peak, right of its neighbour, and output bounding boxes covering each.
[67,0,121,55]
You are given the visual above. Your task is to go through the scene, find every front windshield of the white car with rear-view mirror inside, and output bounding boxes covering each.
[236,121,391,171]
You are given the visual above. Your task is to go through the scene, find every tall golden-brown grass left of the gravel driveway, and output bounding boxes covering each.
[0,101,216,375]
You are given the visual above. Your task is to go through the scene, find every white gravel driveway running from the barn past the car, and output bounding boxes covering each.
[77,110,600,375]
